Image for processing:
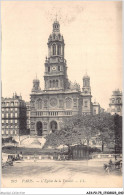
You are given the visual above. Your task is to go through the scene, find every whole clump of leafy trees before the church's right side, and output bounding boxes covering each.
[45,113,122,152]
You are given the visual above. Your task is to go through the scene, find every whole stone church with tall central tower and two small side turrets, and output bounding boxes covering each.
[30,20,99,136]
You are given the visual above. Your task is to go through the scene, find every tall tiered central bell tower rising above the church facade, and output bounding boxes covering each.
[44,19,68,91]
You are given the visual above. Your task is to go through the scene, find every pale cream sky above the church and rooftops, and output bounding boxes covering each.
[1,1,122,109]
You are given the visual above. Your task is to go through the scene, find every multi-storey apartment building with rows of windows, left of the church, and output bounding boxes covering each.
[1,94,27,137]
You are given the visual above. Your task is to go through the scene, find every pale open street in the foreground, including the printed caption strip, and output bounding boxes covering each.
[2,160,122,188]
